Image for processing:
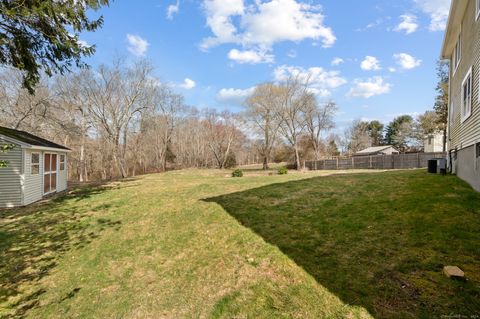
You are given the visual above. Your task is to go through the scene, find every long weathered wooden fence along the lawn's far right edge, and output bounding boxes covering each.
[304,153,447,170]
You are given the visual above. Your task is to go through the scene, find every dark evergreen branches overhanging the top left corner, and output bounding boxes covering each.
[0,0,109,93]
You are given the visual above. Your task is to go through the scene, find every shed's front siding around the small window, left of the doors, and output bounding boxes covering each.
[23,150,43,205]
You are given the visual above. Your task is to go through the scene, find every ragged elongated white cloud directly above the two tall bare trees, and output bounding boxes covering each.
[273,65,347,97]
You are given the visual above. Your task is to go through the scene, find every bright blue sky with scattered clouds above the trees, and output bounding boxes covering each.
[81,0,450,127]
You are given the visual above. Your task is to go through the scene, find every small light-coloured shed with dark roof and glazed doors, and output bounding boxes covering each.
[0,126,71,208]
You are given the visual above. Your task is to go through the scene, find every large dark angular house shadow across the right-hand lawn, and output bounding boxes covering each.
[205,171,480,318]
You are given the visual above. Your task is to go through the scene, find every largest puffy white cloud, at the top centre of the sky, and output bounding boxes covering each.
[201,0,336,49]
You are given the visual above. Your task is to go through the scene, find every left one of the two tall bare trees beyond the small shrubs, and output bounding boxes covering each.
[245,83,281,170]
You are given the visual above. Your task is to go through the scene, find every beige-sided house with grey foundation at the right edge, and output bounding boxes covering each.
[441,0,480,191]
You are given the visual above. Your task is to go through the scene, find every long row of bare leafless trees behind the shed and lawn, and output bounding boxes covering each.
[0,61,342,181]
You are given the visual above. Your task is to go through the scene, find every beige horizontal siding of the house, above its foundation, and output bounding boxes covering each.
[449,0,480,150]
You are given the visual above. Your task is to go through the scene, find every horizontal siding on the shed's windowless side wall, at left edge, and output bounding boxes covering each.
[0,137,23,208]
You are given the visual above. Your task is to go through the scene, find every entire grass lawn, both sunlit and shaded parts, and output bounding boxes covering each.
[0,170,480,318]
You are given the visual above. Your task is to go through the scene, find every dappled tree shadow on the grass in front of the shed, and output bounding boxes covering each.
[0,185,121,317]
